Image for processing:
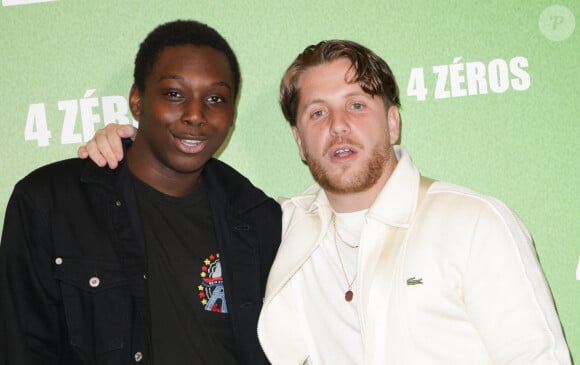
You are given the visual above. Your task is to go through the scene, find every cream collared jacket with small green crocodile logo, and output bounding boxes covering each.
[258,147,571,365]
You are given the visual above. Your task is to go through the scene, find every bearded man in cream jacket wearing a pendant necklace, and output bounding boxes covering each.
[258,40,571,365]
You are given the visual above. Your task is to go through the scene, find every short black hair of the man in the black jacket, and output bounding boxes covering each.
[133,20,240,96]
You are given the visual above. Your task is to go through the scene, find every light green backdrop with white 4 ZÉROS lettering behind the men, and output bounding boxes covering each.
[0,0,580,359]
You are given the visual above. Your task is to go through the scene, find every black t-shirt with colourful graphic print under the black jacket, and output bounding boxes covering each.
[134,178,237,365]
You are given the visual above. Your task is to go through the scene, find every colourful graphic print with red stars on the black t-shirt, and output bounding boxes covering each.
[197,253,228,313]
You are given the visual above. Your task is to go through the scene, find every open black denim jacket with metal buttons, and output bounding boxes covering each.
[0,154,281,365]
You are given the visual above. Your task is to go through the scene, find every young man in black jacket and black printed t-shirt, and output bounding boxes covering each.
[0,21,281,365]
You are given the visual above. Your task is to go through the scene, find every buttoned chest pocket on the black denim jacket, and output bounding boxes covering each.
[55,258,131,353]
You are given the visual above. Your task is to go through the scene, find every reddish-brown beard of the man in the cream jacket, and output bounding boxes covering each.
[304,141,394,194]
